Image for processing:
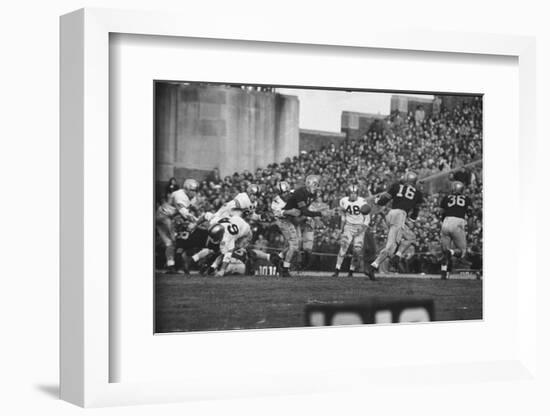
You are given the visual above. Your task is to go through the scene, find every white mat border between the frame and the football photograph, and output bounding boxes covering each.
[111,35,519,381]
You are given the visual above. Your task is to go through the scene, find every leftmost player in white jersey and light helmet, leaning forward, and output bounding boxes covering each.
[155,179,199,271]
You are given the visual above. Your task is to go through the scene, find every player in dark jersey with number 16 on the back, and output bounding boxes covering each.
[365,172,423,280]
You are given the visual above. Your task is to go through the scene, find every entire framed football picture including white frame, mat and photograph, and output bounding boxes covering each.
[61,9,537,406]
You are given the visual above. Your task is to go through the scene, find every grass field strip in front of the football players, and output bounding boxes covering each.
[155,273,482,332]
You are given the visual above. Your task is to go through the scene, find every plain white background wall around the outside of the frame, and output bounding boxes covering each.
[0,0,550,416]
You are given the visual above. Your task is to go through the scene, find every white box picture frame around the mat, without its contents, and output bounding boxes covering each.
[60,9,537,407]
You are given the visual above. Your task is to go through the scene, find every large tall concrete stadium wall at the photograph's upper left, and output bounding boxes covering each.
[155,83,299,181]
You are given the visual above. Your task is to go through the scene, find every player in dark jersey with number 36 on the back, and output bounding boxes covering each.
[439,181,472,279]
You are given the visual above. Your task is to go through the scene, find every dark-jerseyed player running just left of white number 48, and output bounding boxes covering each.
[277,175,329,277]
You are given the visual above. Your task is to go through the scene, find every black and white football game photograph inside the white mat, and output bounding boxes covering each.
[152,80,483,333]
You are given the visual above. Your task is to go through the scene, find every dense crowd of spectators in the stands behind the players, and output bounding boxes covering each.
[160,98,483,272]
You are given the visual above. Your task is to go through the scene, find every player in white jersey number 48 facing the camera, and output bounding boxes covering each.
[332,185,370,277]
